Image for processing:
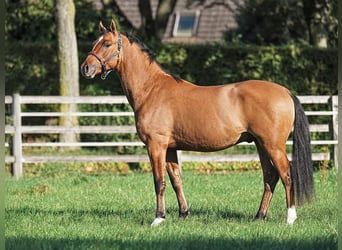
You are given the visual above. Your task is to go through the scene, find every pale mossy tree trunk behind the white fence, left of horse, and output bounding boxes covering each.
[56,0,79,148]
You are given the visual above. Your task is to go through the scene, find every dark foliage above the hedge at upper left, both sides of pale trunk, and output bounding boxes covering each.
[5,0,121,43]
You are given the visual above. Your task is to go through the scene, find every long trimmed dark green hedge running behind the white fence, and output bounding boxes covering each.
[5,42,338,95]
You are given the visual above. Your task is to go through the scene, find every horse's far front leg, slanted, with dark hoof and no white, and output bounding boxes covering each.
[166,150,189,218]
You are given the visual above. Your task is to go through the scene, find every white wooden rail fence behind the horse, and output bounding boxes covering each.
[5,94,338,178]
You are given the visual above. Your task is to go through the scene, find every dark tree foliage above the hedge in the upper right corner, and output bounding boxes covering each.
[226,0,338,47]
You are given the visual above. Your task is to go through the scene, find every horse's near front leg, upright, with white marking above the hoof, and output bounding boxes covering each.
[147,142,166,226]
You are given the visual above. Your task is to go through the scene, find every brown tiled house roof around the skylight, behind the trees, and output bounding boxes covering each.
[94,0,243,43]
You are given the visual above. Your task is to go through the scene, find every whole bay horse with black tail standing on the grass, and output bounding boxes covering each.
[81,20,314,226]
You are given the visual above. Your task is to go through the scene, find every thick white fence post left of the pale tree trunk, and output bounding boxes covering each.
[12,94,23,179]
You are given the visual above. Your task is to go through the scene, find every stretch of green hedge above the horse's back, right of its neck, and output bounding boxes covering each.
[157,44,337,95]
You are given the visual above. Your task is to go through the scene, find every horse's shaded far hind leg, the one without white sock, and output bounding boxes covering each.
[255,142,279,219]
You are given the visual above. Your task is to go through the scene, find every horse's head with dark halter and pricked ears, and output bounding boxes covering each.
[81,20,122,79]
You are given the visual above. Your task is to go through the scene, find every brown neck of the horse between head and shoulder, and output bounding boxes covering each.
[119,41,162,111]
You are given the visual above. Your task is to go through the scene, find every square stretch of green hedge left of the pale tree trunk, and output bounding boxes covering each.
[5,42,59,95]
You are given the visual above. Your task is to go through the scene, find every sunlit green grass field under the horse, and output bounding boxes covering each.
[5,170,338,250]
